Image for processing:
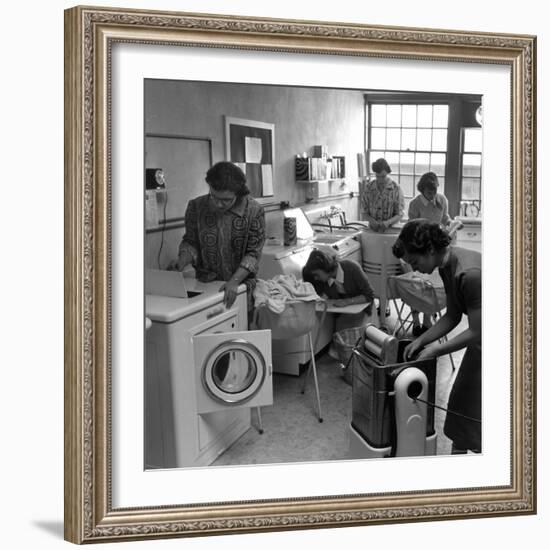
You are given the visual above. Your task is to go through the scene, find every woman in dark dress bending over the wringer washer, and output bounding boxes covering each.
[393,219,481,453]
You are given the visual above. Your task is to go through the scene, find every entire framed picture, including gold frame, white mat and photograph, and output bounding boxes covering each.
[58,3,536,542]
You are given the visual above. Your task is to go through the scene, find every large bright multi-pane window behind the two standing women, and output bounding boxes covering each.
[367,103,449,198]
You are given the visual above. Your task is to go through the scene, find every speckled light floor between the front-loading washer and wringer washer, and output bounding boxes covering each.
[212,310,467,466]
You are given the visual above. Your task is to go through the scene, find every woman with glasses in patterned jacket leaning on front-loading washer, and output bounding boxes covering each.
[178,161,265,311]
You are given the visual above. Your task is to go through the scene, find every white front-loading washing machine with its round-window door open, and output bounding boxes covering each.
[145,272,273,468]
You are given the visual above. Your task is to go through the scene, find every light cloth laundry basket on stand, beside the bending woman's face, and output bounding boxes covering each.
[388,272,447,314]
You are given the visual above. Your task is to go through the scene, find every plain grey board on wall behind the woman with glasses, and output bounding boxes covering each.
[144,134,212,231]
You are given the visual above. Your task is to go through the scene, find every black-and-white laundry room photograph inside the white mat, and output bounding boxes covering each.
[143,78,485,470]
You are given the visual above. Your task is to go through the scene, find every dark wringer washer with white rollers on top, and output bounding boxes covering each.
[349,324,437,458]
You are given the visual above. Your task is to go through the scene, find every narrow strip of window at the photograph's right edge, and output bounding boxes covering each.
[460,128,481,216]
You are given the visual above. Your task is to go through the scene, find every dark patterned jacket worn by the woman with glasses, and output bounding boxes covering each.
[178,195,265,308]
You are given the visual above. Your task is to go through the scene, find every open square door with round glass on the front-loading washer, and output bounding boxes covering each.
[192,330,271,412]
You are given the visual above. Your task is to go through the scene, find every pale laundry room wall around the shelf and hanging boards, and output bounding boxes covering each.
[145,80,364,268]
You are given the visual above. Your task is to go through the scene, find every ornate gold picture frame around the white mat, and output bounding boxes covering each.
[64,7,536,543]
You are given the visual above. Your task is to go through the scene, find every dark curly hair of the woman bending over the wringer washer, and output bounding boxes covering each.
[392,218,451,258]
